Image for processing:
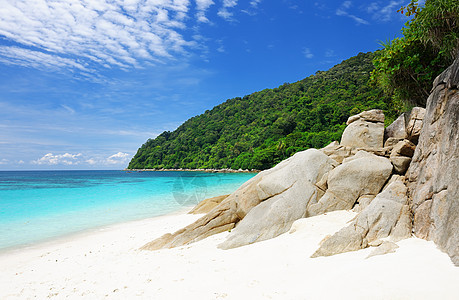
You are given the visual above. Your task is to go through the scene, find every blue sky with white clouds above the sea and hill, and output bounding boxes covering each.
[0,0,408,170]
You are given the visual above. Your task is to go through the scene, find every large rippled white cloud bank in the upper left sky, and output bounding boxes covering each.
[0,0,196,73]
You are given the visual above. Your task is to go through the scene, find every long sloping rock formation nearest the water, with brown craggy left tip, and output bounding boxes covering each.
[142,149,337,250]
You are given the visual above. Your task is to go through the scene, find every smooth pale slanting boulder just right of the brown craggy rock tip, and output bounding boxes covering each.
[219,149,336,249]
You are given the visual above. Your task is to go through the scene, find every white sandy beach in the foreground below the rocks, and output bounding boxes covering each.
[0,211,459,299]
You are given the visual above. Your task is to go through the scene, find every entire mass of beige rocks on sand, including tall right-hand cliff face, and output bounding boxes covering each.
[142,61,459,264]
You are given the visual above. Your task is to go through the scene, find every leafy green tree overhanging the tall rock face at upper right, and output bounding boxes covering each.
[372,0,459,106]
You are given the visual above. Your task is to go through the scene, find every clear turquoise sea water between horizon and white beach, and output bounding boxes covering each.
[0,171,255,250]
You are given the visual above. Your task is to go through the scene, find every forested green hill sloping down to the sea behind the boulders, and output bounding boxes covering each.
[128,53,398,169]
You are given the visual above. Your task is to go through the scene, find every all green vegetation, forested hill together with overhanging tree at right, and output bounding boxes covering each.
[128,0,459,169]
